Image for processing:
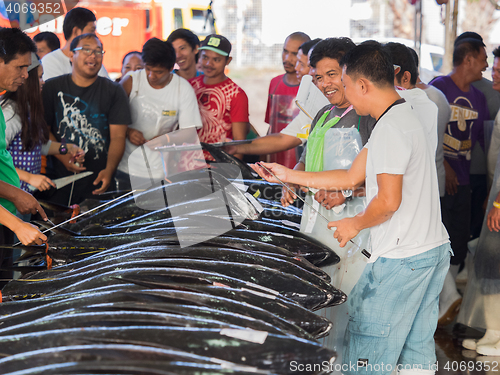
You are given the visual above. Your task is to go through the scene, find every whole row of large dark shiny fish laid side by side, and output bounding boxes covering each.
[0,151,346,374]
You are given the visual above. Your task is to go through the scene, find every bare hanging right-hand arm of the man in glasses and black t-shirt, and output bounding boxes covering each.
[92,125,127,194]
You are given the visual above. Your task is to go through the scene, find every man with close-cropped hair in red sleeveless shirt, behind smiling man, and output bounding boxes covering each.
[265,31,311,168]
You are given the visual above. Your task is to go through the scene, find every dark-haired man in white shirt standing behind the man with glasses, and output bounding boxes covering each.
[42,8,109,81]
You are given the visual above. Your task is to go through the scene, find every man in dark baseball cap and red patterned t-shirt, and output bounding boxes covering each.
[190,34,250,166]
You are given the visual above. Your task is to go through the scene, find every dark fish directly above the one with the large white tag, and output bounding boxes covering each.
[0,288,316,338]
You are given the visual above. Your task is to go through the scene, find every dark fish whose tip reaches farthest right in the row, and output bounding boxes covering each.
[2,258,346,309]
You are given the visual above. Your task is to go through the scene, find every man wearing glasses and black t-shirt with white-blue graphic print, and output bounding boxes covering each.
[42,34,131,206]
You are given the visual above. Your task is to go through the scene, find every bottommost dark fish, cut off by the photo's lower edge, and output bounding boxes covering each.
[0,343,268,375]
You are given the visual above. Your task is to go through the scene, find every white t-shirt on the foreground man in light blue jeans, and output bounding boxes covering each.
[365,103,449,263]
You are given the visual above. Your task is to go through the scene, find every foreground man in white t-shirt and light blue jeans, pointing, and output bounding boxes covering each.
[255,41,451,375]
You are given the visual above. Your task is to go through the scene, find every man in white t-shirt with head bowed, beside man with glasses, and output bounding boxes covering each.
[116,38,202,190]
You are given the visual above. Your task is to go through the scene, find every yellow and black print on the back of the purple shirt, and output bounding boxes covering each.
[443,96,479,160]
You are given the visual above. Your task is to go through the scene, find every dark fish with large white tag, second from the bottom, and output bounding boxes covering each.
[0,326,336,374]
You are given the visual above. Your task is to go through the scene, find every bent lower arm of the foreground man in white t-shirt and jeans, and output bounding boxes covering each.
[328,173,403,247]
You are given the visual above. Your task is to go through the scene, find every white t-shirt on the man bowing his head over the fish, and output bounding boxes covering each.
[118,69,202,179]
